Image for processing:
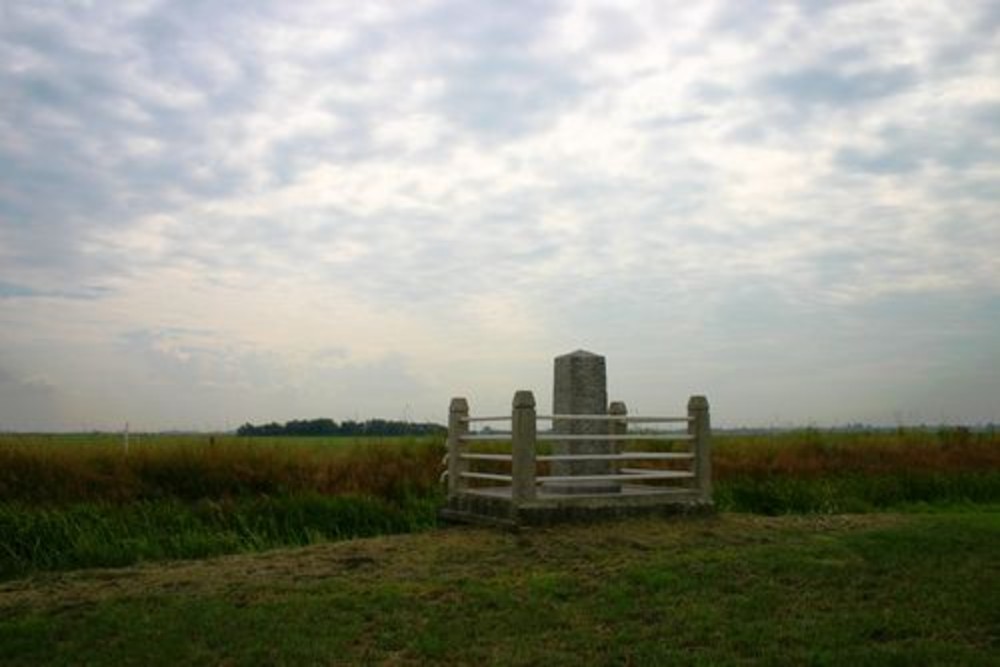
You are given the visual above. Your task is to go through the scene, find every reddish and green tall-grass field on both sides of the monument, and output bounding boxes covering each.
[0,429,1000,578]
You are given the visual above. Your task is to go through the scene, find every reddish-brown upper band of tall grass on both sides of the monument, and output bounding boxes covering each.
[0,428,1000,509]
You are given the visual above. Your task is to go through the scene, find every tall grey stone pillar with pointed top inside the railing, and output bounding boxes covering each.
[546,350,621,493]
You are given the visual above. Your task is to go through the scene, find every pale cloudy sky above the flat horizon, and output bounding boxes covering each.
[0,0,1000,431]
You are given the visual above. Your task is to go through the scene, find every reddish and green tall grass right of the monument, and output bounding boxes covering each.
[712,428,1000,514]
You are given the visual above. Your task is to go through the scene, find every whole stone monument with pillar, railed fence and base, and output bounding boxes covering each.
[441,350,713,527]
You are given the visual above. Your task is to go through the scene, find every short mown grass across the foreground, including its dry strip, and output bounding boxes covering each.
[0,506,1000,665]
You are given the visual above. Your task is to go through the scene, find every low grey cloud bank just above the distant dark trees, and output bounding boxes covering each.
[111,328,432,426]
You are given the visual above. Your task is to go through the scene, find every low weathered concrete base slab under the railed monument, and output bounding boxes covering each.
[440,484,715,528]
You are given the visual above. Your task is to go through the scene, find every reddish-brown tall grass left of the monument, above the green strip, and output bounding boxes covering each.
[0,436,444,504]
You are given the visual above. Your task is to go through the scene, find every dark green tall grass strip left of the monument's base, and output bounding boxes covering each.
[0,494,440,579]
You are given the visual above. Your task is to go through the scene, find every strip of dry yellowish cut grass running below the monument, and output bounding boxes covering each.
[0,514,913,615]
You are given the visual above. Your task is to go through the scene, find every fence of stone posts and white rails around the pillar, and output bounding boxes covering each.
[445,391,712,519]
